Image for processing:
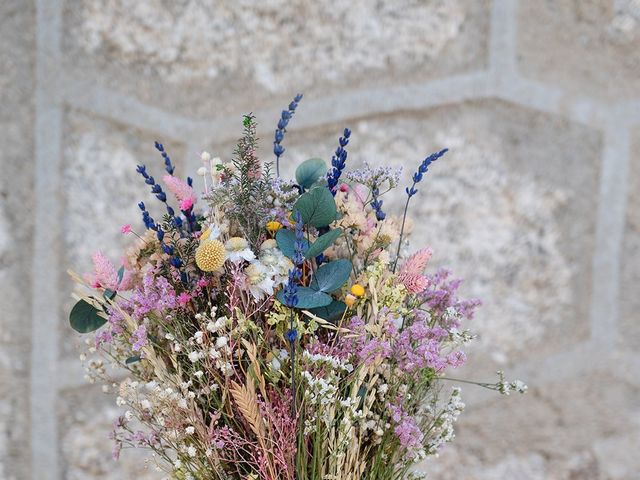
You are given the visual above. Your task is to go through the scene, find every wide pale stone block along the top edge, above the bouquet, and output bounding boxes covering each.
[65,0,489,117]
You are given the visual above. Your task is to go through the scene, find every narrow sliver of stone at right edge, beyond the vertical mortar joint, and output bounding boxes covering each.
[620,130,640,349]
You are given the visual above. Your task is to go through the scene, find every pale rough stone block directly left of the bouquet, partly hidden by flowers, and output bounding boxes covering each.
[61,111,185,353]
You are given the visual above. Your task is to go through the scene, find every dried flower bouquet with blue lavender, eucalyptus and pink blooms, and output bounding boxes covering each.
[70,96,526,480]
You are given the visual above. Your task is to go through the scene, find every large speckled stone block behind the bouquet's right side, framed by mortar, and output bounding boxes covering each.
[276,102,601,363]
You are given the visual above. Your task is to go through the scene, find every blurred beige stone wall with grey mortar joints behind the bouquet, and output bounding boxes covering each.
[0,0,640,480]
